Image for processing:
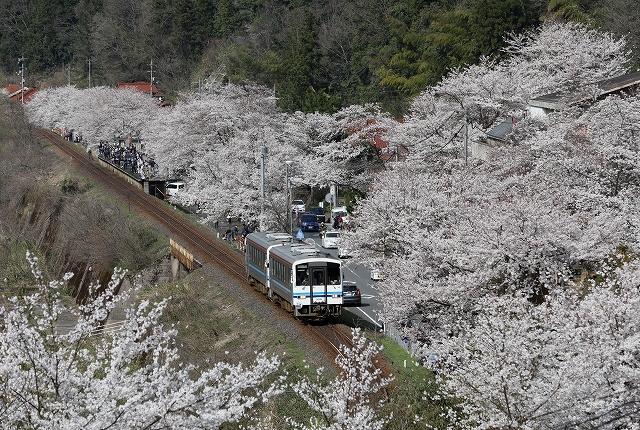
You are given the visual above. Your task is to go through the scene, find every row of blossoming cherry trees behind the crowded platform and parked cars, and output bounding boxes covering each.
[27,84,384,228]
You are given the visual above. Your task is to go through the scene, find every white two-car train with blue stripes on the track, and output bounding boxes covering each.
[245,232,342,320]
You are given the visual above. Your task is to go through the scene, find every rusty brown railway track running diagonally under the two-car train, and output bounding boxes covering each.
[37,130,358,360]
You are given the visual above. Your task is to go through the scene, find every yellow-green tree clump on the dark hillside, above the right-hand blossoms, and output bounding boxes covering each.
[377,0,537,97]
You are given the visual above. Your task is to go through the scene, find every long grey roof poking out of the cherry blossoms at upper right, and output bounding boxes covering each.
[529,72,640,110]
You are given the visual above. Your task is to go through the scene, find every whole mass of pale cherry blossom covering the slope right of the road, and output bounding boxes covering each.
[345,24,640,428]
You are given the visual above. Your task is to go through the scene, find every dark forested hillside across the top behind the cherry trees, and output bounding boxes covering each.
[0,0,640,114]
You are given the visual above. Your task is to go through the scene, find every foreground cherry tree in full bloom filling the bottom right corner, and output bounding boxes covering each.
[428,256,640,429]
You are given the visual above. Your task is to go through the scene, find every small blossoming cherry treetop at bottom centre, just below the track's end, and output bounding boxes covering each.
[293,329,393,430]
